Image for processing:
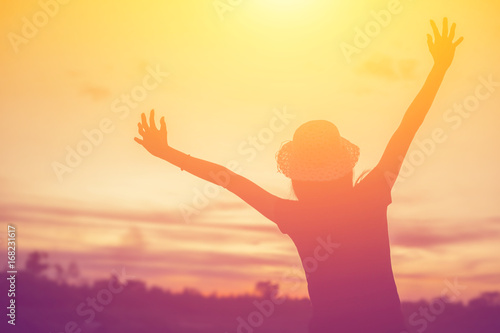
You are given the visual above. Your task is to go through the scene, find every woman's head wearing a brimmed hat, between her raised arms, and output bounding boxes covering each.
[276,120,359,200]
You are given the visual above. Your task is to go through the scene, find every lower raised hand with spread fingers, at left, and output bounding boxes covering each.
[134,110,169,157]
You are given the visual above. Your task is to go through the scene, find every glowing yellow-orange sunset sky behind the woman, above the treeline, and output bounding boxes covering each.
[0,0,500,300]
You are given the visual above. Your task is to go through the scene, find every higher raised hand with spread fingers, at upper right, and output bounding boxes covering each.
[427,17,464,70]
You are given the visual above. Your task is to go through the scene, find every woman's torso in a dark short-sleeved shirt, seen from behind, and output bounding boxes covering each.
[276,178,401,332]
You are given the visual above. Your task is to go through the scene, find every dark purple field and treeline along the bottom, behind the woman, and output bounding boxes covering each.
[0,253,500,333]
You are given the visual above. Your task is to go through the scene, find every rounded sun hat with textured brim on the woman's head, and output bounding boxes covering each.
[276,120,359,181]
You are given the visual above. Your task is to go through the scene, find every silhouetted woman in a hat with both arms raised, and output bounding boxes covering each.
[135,18,463,333]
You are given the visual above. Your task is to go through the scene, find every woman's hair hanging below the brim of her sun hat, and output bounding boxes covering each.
[292,170,370,201]
